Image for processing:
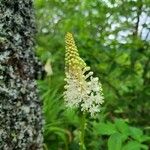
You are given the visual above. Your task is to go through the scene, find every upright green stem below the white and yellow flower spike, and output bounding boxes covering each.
[80,113,86,150]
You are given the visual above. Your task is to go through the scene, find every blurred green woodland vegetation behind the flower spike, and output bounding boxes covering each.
[34,0,150,150]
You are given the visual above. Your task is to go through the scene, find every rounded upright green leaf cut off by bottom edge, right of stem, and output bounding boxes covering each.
[108,132,122,150]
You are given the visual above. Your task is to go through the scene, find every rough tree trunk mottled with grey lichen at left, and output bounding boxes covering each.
[0,0,43,150]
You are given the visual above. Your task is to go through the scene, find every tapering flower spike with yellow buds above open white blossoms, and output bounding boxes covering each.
[64,33,104,117]
